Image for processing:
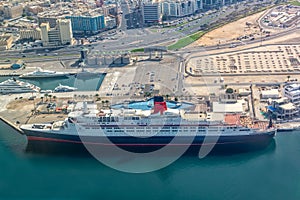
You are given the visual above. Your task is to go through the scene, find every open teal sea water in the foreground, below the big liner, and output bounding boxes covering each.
[0,119,300,200]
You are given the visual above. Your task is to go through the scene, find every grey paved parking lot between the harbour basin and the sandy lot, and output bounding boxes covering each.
[99,57,179,98]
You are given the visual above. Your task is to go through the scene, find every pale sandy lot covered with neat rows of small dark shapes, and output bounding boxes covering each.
[188,44,300,75]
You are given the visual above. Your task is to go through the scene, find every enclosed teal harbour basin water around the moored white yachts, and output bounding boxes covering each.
[0,74,105,91]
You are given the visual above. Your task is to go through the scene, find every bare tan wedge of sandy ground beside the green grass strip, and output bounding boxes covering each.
[189,11,274,47]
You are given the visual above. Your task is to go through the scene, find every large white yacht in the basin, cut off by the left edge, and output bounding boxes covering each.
[0,78,41,94]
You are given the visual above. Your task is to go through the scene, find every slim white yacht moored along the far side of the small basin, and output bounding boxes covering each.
[20,68,70,79]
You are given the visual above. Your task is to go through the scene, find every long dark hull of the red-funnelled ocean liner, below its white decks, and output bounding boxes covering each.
[24,130,275,154]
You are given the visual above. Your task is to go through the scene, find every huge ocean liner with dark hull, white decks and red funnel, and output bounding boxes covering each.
[20,96,276,152]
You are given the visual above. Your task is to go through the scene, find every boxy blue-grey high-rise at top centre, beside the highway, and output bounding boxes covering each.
[142,3,161,23]
